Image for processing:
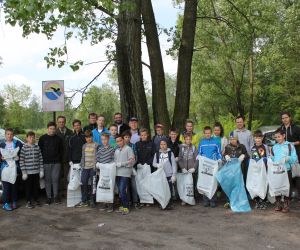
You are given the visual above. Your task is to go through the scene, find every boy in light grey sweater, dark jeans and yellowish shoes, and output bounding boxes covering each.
[114,135,135,215]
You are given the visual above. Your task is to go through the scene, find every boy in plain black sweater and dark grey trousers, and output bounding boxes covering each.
[38,122,64,205]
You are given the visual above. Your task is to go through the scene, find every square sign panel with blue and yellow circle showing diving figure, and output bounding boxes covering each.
[42,80,65,112]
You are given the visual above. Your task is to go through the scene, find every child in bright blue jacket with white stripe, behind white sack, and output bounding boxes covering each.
[198,126,222,208]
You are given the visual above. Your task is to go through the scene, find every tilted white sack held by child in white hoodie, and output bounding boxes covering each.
[142,168,171,209]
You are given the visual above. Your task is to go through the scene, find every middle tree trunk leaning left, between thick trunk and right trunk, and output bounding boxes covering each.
[142,0,171,132]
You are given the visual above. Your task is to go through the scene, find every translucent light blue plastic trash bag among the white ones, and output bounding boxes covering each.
[216,158,251,212]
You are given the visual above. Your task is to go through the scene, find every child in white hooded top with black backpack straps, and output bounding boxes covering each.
[152,139,177,209]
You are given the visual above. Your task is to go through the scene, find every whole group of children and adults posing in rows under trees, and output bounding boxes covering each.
[0,112,300,215]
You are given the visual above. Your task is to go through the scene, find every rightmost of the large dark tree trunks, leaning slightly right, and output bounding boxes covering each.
[172,0,198,132]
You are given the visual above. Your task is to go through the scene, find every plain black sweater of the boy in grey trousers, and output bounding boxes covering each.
[38,134,64,164]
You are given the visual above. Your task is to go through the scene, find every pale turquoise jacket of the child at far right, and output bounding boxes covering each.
[271,141,298,171]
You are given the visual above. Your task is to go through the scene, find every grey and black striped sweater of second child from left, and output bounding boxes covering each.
[20,143,44,174]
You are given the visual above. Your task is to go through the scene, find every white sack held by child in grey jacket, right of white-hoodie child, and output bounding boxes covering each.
[176,173,196,205]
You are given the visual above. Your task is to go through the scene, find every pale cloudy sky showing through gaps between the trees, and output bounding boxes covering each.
[0,0,181,106]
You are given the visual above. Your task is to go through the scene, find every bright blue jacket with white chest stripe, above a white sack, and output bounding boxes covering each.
[198,138,222,160]
